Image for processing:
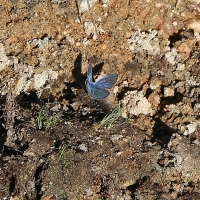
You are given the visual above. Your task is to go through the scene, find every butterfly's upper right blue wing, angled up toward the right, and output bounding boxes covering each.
[95,74,118,89]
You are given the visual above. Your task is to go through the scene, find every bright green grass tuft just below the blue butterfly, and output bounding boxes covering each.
[100,104,128,129]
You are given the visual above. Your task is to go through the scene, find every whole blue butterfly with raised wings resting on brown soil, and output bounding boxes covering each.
[85,63,118,100]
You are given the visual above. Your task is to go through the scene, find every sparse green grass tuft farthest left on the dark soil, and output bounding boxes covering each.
[36,110,62,130]
